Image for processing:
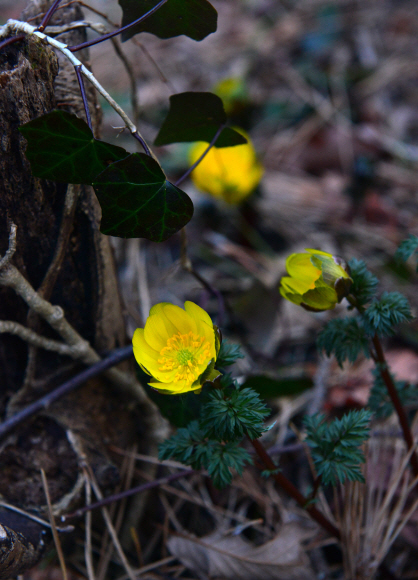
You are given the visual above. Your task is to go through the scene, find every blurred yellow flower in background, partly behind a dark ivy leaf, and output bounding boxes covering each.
[189,127,263,205]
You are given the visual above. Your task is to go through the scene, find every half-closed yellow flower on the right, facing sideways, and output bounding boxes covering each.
[280,248,353,312]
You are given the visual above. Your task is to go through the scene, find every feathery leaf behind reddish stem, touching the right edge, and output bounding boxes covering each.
[368,365,418,419]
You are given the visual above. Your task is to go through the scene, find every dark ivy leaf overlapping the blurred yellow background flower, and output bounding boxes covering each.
[154,92,247,148]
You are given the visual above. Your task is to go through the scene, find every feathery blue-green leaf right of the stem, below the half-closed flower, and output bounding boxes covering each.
[363,292,413,336]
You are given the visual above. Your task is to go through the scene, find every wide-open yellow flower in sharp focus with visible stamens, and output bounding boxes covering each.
[132,302,220,395]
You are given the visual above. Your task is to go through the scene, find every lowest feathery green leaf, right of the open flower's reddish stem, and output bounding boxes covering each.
[304,409,371,485]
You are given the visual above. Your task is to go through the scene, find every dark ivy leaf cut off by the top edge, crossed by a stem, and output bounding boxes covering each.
[119,0,218,42]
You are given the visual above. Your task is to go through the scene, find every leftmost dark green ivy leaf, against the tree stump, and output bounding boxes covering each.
[19,111,129,185]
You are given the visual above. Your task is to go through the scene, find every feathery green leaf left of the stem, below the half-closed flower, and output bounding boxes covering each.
[317,317,369,366]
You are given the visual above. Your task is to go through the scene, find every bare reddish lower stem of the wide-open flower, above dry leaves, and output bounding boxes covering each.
[248,437,341,540]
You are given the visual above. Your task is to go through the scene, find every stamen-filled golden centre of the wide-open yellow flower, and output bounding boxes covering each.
[158,332,210,384]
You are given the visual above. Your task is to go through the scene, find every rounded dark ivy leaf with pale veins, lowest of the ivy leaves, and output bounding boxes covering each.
[93,153,193,242]
